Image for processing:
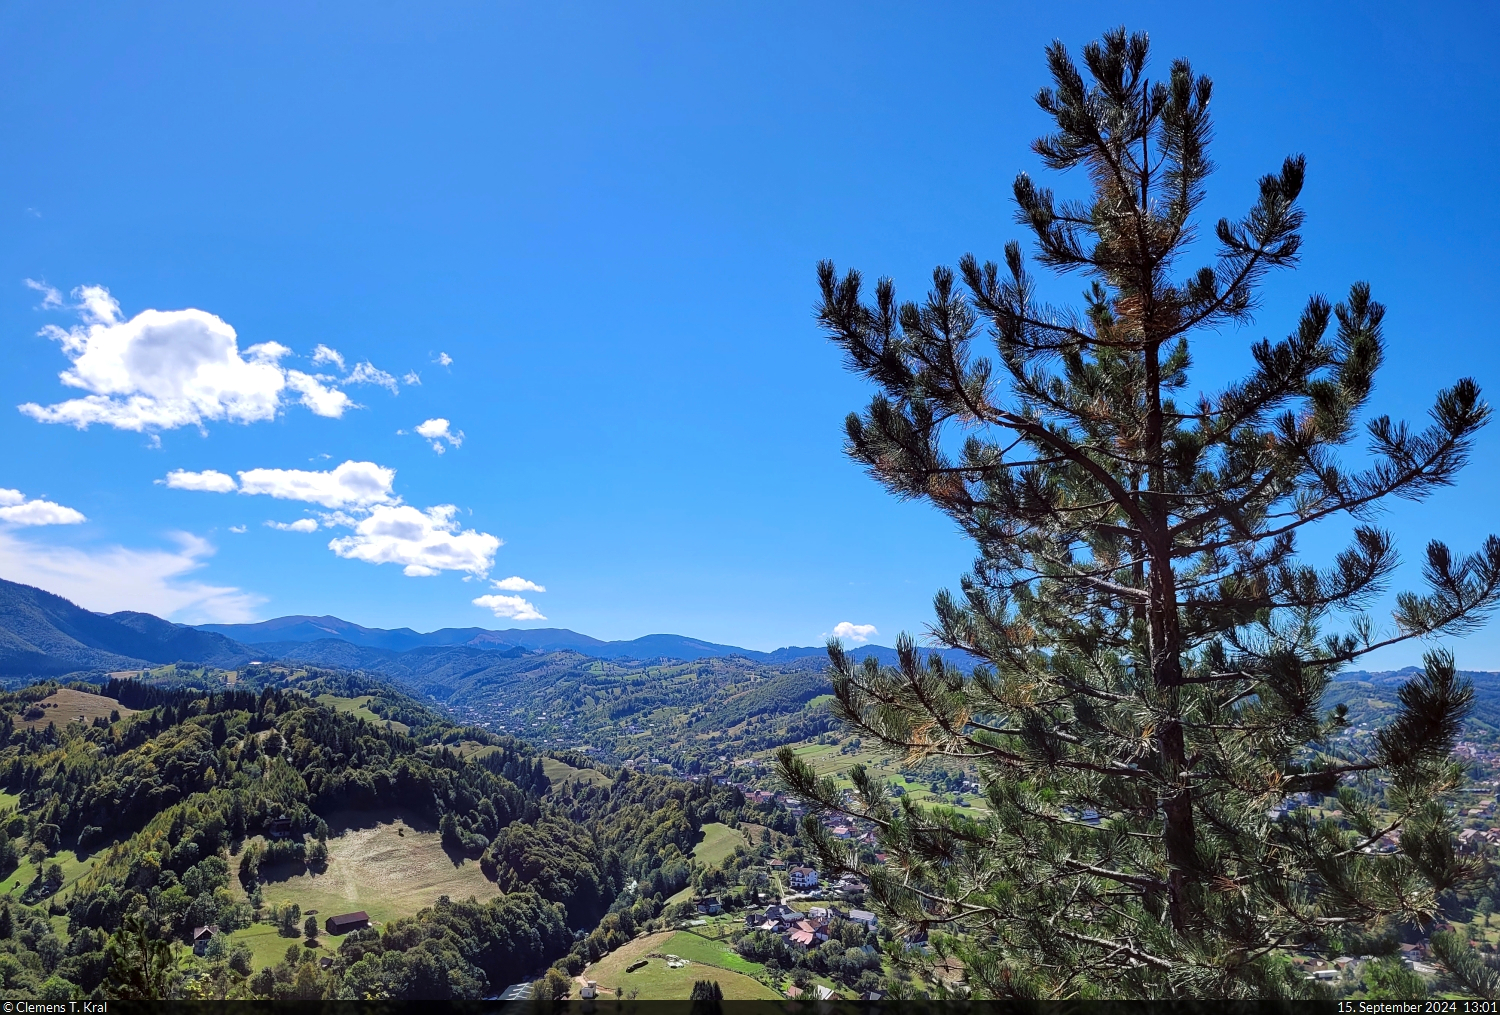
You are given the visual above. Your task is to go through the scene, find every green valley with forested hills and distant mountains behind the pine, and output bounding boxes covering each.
[0,569,1500,1000]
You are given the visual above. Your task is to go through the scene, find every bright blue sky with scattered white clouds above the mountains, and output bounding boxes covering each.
[0,1,1500,667]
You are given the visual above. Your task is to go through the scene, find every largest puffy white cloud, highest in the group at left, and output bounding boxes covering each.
[20,285,353,432]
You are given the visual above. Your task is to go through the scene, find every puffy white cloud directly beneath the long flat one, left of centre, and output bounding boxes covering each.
[328,500,501,577]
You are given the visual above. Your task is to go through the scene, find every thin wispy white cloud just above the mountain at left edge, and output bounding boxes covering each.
[0,529,266,624]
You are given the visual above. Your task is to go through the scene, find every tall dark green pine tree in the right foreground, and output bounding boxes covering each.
[780,28,1500,997]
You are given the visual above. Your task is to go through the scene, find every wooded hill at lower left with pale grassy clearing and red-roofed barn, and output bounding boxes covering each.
[0,667,762,1000]
